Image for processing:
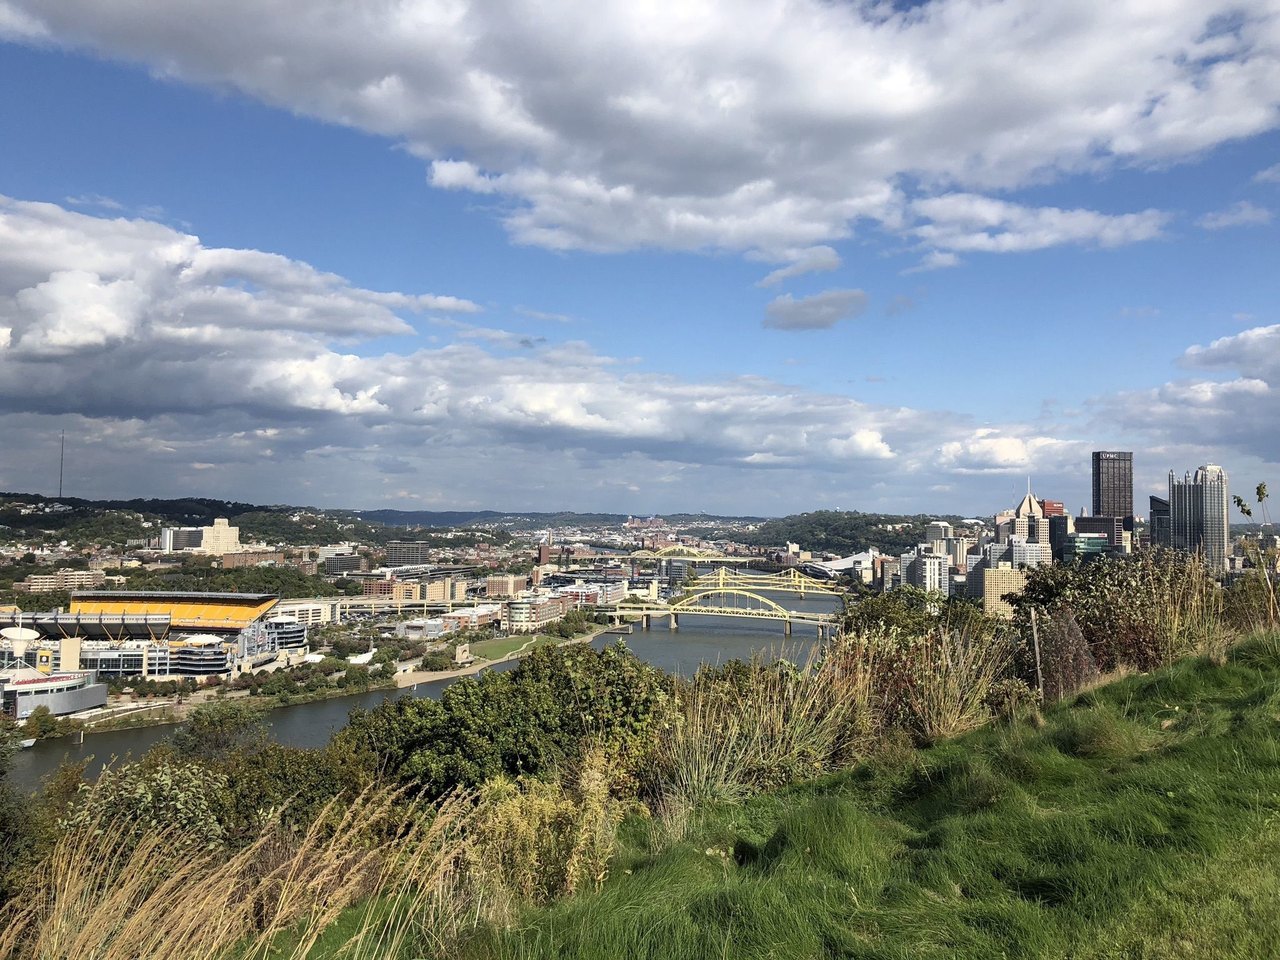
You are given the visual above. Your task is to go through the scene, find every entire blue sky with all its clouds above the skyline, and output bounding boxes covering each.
[0,0,1280,516]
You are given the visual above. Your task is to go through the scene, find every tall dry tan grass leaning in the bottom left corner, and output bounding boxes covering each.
[0,791,470,960]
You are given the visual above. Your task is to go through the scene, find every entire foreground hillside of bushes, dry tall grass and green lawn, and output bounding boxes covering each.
[0,553,1280,960]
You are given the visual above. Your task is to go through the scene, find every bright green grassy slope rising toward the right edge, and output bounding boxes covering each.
[462,646,1280,960]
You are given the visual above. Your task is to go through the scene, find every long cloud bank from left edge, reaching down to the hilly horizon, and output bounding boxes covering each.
[0,192,1131,512]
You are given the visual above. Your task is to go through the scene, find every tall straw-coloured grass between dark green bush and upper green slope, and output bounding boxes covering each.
[652,625,1012,817]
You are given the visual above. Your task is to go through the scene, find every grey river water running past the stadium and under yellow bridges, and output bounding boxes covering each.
[6,594,840,791]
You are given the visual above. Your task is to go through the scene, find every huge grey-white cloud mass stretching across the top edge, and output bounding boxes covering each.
[0,0,1280,259]
